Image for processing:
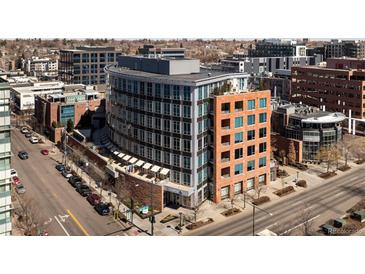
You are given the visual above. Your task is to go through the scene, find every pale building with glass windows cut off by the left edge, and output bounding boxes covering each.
[0,77,12,235]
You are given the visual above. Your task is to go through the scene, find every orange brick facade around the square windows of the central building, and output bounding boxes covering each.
[213,90,270,203]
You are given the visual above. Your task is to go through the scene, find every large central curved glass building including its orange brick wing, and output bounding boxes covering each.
[106,56,270,207]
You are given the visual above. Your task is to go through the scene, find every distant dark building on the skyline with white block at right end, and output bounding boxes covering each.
[248,39,306,57]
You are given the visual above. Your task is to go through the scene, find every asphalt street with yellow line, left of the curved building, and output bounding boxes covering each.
[11,128,125,236]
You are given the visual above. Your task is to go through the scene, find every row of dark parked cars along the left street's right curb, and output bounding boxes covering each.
[56,164,110,216]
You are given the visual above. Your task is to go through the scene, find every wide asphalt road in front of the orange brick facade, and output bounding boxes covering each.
[188,167,365,236]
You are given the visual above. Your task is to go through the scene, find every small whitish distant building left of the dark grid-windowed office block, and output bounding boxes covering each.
[22,57,58,79]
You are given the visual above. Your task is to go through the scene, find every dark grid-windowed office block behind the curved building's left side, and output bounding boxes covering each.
[58,46,121,85]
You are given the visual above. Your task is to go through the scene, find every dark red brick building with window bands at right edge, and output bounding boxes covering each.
[291,59,365,119]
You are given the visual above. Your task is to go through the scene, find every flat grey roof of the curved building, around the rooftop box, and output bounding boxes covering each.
[106,65,248,83]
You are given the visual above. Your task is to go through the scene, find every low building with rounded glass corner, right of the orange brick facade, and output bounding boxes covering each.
[271,101,346,162]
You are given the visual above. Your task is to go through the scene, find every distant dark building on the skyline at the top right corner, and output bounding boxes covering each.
[324,40,365,59]
